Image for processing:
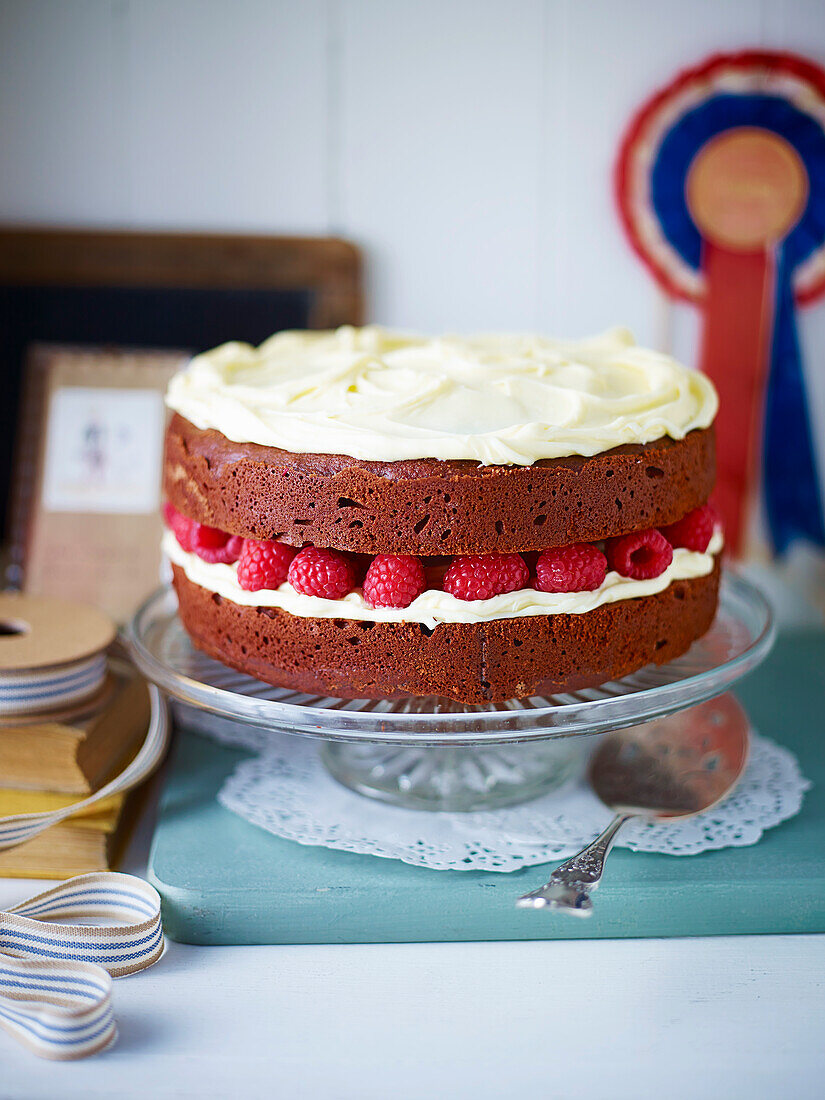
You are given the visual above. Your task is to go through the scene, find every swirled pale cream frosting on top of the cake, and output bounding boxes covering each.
[166,326,718,465]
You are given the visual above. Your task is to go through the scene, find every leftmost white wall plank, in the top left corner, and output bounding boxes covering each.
[0,0,130,224]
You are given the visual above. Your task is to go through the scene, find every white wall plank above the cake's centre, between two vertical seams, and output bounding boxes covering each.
[340,0,547,330]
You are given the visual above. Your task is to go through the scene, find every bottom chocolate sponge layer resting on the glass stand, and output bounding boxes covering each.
[174,562,719,703]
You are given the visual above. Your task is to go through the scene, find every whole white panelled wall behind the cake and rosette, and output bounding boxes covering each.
[0,0,825,334]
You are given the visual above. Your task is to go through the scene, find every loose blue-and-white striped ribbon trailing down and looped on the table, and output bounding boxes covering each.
[0,685,169,1059]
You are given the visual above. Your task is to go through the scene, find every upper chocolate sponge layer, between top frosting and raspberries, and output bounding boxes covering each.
[164,415,715,554]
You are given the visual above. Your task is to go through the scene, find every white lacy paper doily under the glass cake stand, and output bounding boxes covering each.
[185,714,811,871]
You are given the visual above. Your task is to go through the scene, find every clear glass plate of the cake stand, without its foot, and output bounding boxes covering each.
[124,570,774,746]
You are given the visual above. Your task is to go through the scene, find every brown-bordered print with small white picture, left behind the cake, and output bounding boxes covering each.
[9,345,187,622]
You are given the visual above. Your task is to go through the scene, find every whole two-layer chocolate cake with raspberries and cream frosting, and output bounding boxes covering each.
[164,327,723,703]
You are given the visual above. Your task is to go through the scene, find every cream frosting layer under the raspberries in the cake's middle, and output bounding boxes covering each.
[163,528,724,629]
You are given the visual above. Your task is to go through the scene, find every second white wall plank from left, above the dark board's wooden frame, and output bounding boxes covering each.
[125,0,331,233]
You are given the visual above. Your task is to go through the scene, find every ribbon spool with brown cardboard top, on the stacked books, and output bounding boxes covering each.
[0,592,116,717]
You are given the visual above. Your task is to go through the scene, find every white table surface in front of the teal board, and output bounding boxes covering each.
[0,800,825,1100]
